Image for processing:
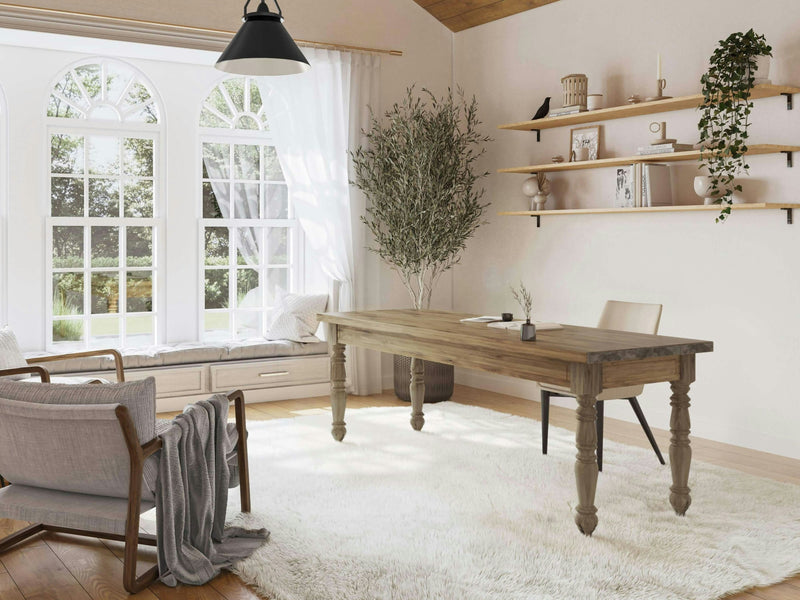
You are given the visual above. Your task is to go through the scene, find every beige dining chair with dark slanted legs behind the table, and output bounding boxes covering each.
[539,300,666,471]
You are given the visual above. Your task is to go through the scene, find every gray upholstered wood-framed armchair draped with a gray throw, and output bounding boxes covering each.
[0,378,250,593]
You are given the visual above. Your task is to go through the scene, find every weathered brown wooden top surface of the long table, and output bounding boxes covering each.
[318,309,714,364]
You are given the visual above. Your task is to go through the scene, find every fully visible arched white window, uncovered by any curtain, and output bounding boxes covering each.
[47,59,162,348]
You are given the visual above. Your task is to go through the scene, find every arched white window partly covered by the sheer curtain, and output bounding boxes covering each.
[200,77,301,340]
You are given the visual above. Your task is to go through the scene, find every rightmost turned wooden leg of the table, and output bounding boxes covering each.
[669,354,695,516]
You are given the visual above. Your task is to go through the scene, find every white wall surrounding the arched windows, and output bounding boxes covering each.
[0,0,452,350]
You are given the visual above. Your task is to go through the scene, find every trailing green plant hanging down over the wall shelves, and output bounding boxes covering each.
[698,29,772,223]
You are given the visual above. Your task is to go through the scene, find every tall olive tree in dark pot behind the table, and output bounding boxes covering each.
[353,88,490,402]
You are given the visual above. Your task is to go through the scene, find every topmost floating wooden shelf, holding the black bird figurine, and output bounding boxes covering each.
[498,85,800,131]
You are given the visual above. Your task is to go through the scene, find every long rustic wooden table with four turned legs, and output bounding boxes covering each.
[319,310,714,535]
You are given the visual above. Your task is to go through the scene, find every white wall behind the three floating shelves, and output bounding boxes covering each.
[454,0,800,458]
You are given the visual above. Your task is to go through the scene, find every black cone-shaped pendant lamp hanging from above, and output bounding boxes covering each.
[215,0,311,76]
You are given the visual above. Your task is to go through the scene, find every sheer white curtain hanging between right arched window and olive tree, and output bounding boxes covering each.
[259,48,381,394]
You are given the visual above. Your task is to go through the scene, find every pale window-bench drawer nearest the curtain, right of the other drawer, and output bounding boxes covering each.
[210,356,330,392]
